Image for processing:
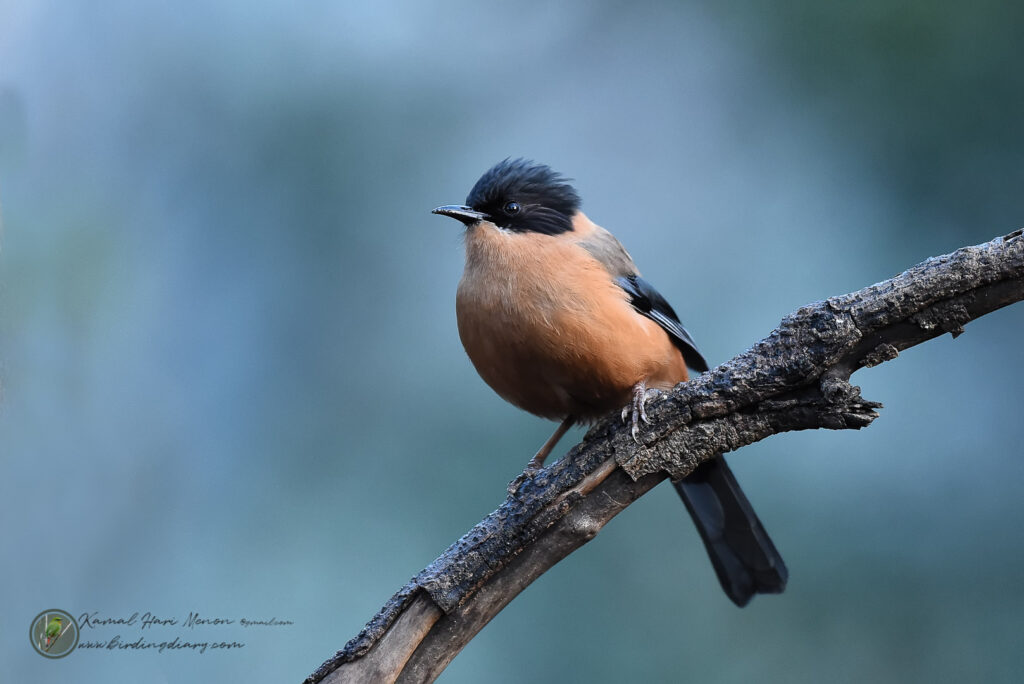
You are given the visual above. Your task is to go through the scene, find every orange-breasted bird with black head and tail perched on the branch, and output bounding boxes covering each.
[432,158,788,607]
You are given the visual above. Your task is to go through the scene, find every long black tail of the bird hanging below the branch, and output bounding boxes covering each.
[673,457,790,607]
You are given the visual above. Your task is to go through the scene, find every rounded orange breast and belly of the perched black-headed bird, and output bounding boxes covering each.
[456,222,687,420]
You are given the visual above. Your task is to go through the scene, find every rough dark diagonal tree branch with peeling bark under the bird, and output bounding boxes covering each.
[306,230,1024,684]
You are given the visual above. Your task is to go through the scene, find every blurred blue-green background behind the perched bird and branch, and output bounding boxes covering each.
[0,0,1024,684]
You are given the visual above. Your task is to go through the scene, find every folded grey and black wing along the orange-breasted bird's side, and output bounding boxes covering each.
[580,224,708,373]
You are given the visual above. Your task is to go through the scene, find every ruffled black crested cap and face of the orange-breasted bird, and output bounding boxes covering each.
[466,159,580,236]
